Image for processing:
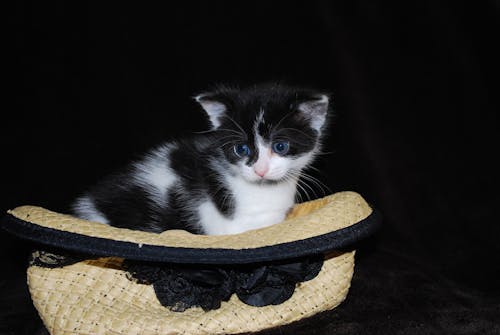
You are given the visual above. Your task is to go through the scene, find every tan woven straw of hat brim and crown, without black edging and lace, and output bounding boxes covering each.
[18,192,371,335]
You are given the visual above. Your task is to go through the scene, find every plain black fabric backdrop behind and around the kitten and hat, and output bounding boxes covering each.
[0,0,500,334]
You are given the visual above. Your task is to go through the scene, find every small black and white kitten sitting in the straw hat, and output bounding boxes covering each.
[72,85,328,235]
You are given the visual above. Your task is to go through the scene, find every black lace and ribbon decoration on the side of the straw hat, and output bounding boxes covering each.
[125,256,323,312]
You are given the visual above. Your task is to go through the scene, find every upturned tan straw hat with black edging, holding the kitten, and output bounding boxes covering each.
[1,192,380,334]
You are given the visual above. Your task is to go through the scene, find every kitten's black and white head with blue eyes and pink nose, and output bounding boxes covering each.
[195,85,329,183]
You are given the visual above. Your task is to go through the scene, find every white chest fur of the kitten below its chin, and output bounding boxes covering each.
[199,177,296,235]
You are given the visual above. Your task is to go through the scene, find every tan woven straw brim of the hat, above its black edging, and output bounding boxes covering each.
[9,192,372,249]
